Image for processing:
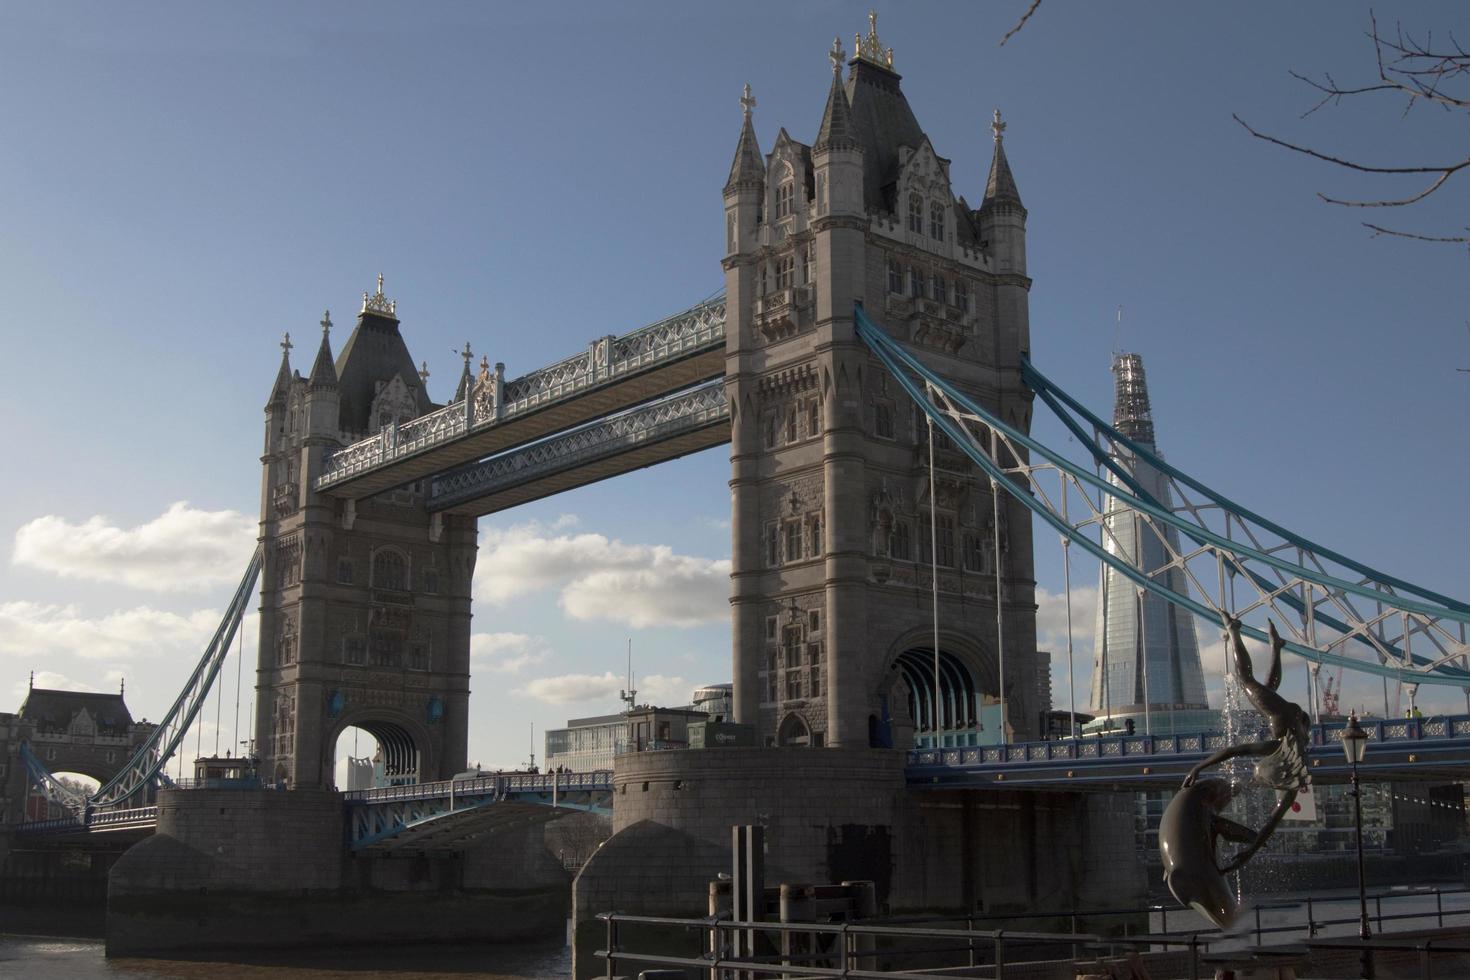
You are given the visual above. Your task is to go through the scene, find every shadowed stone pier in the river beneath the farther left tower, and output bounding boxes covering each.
[106,789,569,955]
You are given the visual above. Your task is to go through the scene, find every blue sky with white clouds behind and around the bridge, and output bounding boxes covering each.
[0,0,1470,764]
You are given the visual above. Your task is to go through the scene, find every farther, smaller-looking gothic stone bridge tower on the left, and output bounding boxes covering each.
[256,276,476,786]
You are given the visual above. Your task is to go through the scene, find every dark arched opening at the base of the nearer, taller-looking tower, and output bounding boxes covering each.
[869,646,1000,748]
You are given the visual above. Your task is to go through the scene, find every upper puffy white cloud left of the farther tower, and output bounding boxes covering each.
[10,501,256,592]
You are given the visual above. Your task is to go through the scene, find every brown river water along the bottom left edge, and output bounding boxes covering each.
[0,934,572,980]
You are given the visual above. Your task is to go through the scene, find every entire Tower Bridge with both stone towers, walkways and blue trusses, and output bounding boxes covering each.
[11,13,1470,974]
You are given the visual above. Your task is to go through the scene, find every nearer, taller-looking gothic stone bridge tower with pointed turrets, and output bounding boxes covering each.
[723,24,1050,746]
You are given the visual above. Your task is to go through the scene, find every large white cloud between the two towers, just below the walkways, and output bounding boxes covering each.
[475,517,731,629]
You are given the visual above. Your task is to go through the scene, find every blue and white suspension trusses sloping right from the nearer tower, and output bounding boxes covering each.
[856,306,1470,688]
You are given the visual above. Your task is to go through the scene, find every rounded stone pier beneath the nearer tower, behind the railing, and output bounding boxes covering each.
[572,748,1145,980]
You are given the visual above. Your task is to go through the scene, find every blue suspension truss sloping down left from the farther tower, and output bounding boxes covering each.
[21,547,262,824]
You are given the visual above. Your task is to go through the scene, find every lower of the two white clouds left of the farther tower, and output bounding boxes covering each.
[0,601,219,660]
